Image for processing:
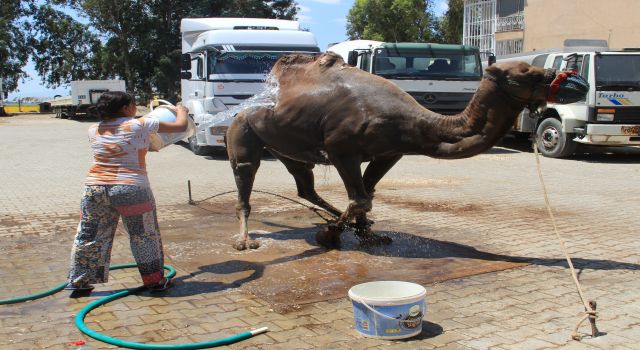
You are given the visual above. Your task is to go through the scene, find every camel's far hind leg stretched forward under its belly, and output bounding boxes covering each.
[272,152,342,217]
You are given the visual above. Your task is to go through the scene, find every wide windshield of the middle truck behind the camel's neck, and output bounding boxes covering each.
[373,49,482,81]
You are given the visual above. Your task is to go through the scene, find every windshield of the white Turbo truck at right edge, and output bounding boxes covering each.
[595,55,640,91]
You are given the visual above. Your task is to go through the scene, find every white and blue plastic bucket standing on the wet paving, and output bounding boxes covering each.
[349,281,427,339]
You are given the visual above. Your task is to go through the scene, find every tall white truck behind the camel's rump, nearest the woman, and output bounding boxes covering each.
[180,18,320,155]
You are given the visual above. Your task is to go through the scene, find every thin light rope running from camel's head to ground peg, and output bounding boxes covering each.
[533,142,598,341]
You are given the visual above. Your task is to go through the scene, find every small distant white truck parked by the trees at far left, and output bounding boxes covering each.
[49,80,126,118]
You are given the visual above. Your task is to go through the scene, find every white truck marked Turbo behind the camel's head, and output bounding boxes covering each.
[498,47,640,158]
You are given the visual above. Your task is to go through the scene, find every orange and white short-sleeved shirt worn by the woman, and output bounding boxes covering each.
[85,117,160,187]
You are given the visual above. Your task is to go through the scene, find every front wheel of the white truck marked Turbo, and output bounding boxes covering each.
[536,118,576,158]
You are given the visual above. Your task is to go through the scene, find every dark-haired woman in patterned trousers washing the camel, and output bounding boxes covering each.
[67,91,187,291]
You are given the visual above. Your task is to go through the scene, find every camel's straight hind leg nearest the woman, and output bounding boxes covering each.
[226,109,271,250]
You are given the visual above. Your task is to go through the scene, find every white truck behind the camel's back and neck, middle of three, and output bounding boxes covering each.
[327,40,482,114]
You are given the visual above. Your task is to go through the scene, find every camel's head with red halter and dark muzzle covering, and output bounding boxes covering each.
[485,61,589,111]
